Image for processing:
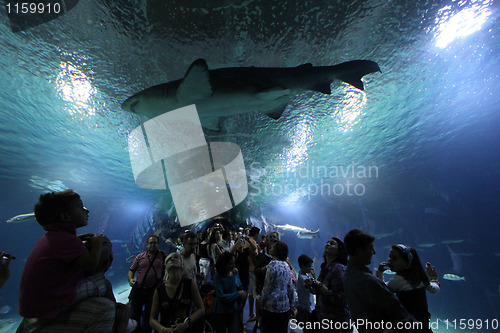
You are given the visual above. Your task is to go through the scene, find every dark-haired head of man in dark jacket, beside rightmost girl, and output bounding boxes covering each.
[344,229,375,265]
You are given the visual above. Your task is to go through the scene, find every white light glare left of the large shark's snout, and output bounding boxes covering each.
[56,62,96,117]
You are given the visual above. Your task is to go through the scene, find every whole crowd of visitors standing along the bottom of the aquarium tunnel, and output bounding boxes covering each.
[5,190,439,333]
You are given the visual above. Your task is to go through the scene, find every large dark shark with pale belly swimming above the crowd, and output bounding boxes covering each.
[121,59,380,131]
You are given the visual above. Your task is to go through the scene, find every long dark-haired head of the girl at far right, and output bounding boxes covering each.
[387,244,429,286]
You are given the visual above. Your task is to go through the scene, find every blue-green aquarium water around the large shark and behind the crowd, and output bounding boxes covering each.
[0,0,500,331]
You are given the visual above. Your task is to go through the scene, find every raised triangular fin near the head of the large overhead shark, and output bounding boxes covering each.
[176,59,213,101]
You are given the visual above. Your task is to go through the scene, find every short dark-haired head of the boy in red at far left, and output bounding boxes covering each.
[34,190,89,228]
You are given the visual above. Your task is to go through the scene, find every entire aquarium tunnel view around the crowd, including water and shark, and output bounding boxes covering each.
[0,0,500,333]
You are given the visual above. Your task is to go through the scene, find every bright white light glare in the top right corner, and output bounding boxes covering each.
[435,0,491,49]
